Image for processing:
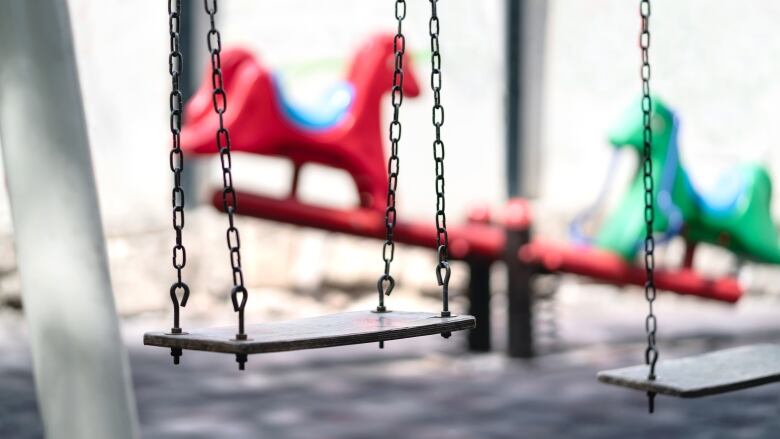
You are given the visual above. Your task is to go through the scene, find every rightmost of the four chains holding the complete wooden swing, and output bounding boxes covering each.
[428,0,451,320]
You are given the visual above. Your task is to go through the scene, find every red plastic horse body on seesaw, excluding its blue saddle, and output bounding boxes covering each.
[181,35,420,210]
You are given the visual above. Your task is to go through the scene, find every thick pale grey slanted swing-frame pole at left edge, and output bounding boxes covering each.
[0,0,138,439]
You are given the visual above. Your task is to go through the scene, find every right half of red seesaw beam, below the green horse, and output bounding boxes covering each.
[518,240,743,303]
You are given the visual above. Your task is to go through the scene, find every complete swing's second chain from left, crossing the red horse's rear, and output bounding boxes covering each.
[203,0,249,344]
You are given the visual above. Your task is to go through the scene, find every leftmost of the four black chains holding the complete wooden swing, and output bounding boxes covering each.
[168,0,190,364]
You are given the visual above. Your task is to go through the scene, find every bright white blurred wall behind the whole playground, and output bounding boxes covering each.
[0,0,780,237]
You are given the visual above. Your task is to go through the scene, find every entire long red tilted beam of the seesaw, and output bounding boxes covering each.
[219,191,743,303]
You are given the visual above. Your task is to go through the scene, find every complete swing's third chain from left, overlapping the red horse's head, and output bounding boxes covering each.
[376,0,406,312]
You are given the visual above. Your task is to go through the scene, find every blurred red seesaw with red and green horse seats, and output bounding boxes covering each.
[168,0,772,370]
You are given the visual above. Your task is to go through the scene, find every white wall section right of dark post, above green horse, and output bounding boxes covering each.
[542,0,780,220]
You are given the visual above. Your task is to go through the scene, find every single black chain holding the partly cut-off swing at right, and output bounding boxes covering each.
[639,0,658,413]
